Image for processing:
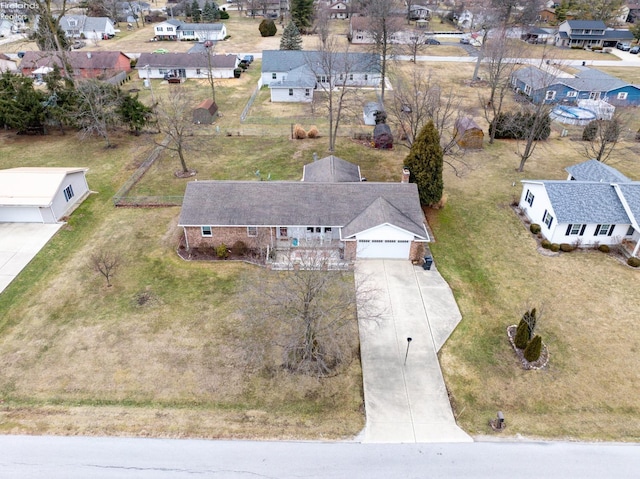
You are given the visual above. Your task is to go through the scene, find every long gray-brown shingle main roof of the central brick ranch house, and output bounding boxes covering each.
[178,181,428,239]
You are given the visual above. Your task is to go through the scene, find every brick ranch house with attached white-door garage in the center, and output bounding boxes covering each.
[178,156,430,262]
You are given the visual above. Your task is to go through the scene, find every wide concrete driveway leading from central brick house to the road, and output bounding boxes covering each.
[356,260,472,443]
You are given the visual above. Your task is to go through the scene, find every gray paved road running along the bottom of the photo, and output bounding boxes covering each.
[0,436,640,479]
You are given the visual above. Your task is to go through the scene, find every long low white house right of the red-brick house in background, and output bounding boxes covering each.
[136,52,240,79]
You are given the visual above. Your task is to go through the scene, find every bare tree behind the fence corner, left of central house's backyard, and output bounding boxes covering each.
[156,86,196,174]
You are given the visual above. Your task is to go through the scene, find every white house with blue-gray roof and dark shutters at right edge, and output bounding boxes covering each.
[519,160,640,256]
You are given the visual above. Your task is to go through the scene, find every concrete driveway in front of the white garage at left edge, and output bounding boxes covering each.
[0,223,62,293]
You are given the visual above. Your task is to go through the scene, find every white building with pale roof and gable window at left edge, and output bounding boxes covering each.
[0,168,89,223]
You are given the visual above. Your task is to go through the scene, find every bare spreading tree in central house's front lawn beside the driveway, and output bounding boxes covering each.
[240,248,378,377]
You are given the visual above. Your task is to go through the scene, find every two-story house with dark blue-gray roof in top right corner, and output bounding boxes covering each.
[555,20,633,48]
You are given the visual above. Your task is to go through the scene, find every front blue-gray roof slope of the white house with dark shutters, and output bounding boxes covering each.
[542,181,631,224]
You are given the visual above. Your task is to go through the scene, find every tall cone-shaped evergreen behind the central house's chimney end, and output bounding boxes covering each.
[404,120,444,206]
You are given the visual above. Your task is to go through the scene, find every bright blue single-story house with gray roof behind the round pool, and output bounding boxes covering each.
[511,66,640,106]
